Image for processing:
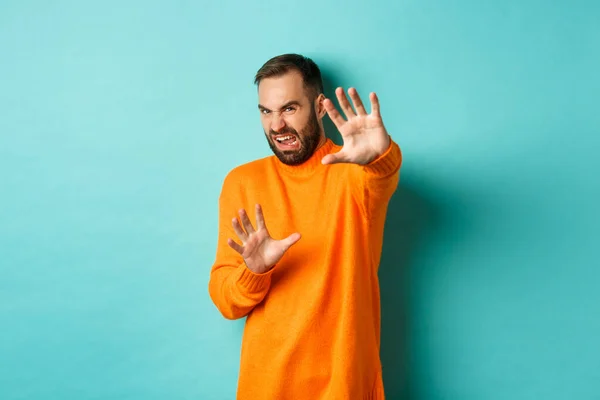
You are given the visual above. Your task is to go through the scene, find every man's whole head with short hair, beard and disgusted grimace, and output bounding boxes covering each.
[254,54,325,165]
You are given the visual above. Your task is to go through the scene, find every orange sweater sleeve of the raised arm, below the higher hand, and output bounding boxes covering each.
[350,138,402,220]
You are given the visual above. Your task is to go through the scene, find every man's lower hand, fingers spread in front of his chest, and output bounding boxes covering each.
[227,204,300,274]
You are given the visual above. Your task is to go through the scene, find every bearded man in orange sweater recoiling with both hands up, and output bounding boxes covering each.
[209,54,402,400]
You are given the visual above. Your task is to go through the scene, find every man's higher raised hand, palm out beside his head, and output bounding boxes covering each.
[321,88,390,165]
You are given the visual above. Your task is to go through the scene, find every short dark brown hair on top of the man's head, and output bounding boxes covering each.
[254,54,323,99]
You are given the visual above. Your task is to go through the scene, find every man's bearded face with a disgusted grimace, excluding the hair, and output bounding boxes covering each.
[258,71,323,165]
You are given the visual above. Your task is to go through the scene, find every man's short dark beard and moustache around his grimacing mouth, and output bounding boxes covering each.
[266,109,321,165]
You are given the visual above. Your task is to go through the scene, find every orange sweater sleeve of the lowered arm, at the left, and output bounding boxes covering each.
[208,173,272,319]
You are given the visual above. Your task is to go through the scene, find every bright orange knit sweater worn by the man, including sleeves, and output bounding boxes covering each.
[209,140,402,400]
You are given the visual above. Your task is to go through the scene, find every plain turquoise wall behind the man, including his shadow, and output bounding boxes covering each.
[0,0,600,400]
